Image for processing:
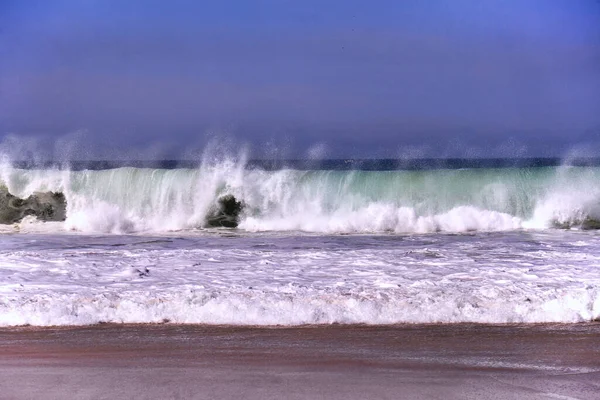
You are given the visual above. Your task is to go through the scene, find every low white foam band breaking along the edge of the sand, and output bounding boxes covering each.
[0,289,600,326]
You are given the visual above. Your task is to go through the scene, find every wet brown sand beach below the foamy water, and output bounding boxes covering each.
[0,323,600,400]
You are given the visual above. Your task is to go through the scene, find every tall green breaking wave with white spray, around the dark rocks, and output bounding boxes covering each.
[0,161,600,233]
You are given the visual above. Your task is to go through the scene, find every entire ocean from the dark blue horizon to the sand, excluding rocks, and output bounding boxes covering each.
[0,157,600,326]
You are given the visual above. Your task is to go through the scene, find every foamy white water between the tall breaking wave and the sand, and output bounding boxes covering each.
[0,233,600,326]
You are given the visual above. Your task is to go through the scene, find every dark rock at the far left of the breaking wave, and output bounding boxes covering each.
[0,186,67,224]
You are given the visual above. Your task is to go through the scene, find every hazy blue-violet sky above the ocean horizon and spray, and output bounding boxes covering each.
[0,0,600,158]
